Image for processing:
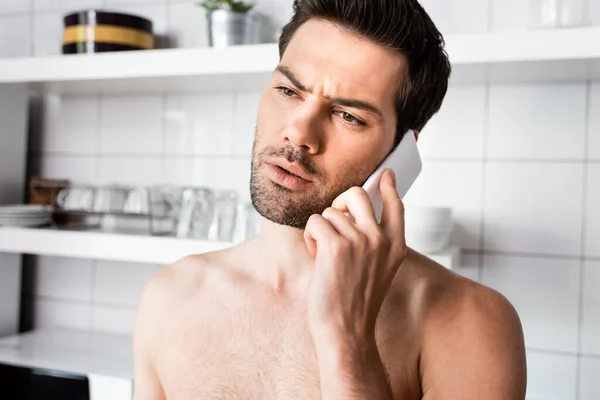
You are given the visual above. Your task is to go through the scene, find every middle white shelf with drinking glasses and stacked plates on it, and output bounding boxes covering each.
[0,227,461,269]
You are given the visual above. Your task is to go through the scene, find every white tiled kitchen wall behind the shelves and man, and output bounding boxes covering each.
[0,0,600,400]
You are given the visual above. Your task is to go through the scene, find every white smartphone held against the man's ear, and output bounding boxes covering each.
[363,130,423,222]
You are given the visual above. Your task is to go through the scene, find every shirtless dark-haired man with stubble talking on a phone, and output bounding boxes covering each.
[134,0,526,400]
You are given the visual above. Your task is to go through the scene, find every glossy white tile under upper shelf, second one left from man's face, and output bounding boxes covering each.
[165,93,235,156]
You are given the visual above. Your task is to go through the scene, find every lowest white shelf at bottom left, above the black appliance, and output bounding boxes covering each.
[0,329,133,380]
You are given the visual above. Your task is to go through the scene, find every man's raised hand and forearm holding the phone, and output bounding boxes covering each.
[304,170,407,400]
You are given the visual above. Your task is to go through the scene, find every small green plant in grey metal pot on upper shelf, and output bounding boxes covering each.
[198,0,254,47]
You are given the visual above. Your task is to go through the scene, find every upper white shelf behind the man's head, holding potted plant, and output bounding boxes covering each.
[0,27,600,94]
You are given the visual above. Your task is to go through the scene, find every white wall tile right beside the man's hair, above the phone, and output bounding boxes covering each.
[418,85,487,160]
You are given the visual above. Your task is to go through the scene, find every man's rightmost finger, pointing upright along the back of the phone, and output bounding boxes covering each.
[379,170,404,234]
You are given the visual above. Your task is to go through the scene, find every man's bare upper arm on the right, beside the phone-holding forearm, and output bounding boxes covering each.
[421,284,527,400]
